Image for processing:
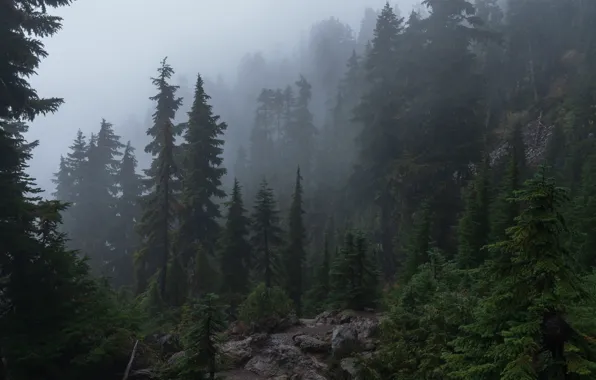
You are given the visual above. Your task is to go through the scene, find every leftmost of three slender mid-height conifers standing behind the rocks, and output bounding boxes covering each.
[219,179,252,311]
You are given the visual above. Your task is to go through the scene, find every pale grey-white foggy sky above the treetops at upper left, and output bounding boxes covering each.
[29,0,414,194]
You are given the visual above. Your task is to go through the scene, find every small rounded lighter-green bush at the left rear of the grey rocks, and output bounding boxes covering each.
[238,283,294,329]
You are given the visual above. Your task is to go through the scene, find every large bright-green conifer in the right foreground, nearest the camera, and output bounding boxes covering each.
[450,167,594,379]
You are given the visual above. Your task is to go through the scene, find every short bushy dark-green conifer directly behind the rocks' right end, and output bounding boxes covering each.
[330,232,379,310]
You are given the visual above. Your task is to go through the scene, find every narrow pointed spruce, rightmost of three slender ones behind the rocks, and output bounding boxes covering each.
[284,168,306,316]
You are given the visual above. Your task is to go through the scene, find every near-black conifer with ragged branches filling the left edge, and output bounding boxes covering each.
[0,0,141,380]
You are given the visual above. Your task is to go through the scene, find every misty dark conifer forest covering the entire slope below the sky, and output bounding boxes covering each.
[0,0,596,380]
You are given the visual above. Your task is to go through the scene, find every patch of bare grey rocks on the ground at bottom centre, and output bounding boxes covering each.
[131,311,381,380]
